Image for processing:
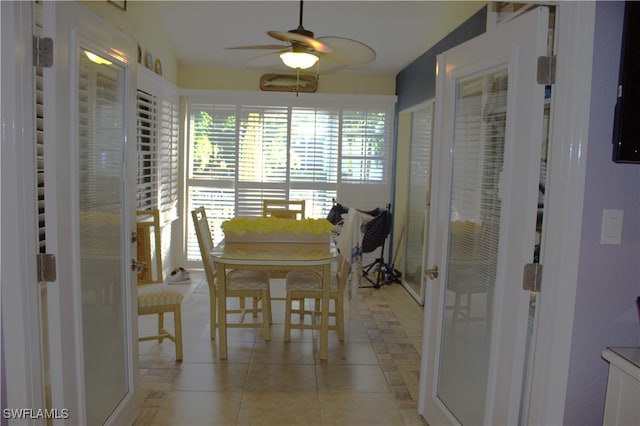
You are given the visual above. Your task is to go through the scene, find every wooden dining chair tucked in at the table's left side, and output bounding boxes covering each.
[191,207,272,340]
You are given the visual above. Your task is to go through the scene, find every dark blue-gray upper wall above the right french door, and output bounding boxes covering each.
[396,6,487,111]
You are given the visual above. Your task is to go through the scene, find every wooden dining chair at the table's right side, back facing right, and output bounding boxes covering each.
[284,255,351,342]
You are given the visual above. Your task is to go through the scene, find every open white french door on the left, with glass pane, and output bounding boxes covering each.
[43,2,139,425]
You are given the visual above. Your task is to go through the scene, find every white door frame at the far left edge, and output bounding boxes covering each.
[0,2,45,424]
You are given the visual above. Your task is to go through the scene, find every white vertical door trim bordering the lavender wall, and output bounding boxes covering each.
[526,2,596,425]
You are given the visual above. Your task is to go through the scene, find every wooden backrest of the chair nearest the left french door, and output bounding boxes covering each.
[136,209,162,285]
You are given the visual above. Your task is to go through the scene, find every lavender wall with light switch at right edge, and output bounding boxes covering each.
[558,1,640,426]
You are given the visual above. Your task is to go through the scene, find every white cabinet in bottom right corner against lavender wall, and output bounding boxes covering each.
[602,348,640,425]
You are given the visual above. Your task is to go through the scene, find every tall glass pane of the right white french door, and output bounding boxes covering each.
[438,69,508,424]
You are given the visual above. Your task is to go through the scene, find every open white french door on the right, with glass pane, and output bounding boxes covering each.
[419,7,549,425]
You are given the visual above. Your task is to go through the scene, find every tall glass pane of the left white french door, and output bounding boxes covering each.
[77,48,130,424]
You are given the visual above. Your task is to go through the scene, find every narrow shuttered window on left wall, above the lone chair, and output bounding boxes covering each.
[136,70,179,222]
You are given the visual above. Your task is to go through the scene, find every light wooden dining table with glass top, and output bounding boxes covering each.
[211,240,338,360]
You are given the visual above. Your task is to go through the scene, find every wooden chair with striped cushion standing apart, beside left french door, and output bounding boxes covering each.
[137,210,184,361]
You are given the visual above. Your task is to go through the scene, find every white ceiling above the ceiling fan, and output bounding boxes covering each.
[157,0,486,75]
